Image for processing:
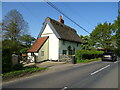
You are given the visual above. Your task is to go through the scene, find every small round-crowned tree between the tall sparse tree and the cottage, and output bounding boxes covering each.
[20,34,35,46]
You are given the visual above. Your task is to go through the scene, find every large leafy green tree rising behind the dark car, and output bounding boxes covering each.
[90,22,115,50]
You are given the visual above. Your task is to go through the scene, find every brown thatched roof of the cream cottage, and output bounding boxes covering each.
[39,17,82,43]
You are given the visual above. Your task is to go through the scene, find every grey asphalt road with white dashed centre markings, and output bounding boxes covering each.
[3,61,119,90]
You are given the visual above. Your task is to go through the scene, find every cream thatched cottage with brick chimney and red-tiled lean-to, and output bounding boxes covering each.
[28,16,82,62]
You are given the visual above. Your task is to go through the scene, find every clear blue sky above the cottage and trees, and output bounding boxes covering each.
[2,2,118,38]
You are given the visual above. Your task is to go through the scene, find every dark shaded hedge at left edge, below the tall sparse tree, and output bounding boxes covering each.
[2,40,21,73]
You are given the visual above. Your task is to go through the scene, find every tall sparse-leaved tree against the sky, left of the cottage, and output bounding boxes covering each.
[2,10,28,41]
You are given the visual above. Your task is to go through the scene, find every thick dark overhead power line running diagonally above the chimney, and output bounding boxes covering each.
[44,0,90,34]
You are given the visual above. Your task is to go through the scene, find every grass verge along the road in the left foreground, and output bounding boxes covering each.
[2,67,47,79]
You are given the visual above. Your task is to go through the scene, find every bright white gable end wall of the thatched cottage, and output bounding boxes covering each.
[41,24,59,60]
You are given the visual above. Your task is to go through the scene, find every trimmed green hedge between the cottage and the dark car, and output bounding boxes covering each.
[75,50,103,60]
